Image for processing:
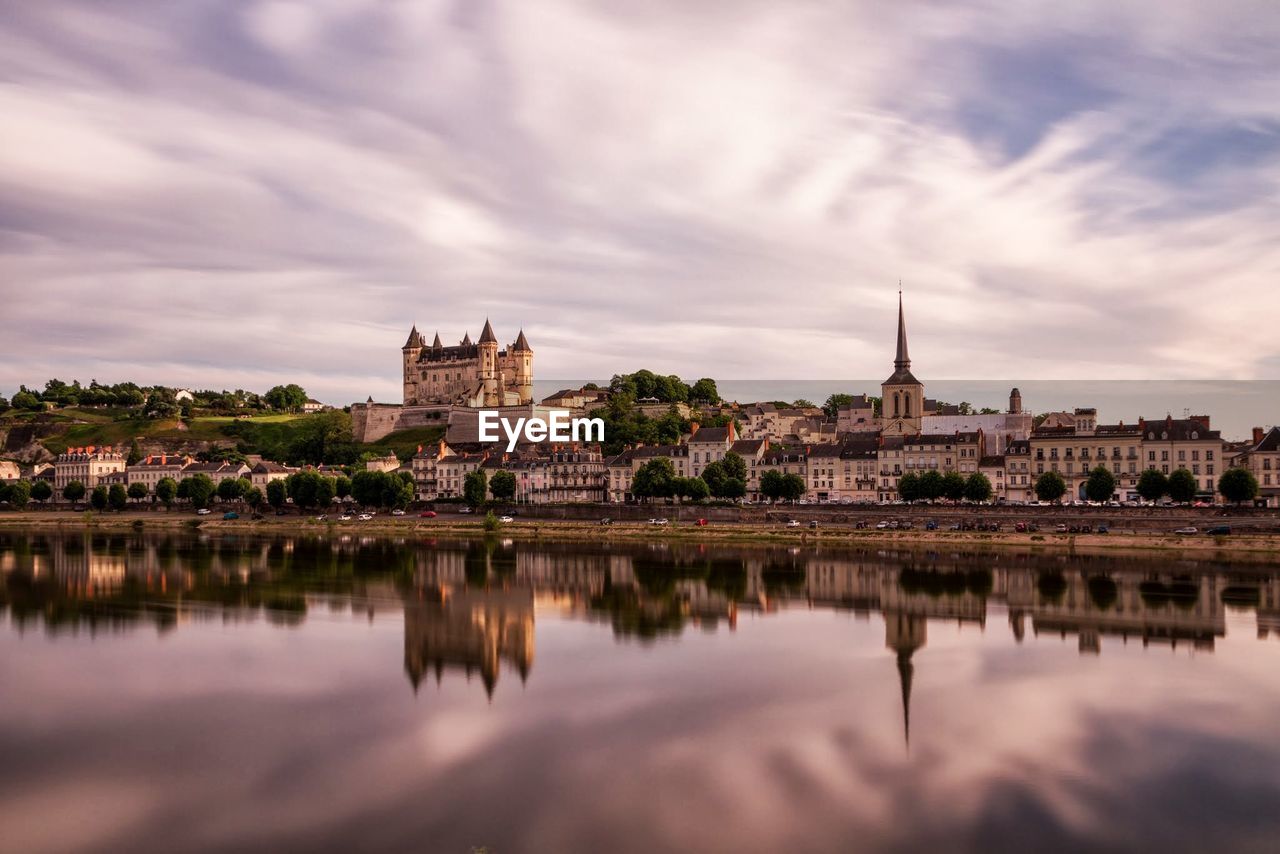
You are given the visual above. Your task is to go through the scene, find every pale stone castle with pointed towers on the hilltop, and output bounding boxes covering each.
[402,320,534,407]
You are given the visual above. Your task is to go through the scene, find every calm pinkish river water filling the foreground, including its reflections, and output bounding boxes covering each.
[0,531,1280,853]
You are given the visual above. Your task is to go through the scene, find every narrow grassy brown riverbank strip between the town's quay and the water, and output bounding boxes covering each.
[0,512,1280,563]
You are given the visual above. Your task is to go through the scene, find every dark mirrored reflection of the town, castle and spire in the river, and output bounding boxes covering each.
[0,533,1280,740]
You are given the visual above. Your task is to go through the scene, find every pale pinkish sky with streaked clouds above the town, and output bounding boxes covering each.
[0,0,1280,402]
